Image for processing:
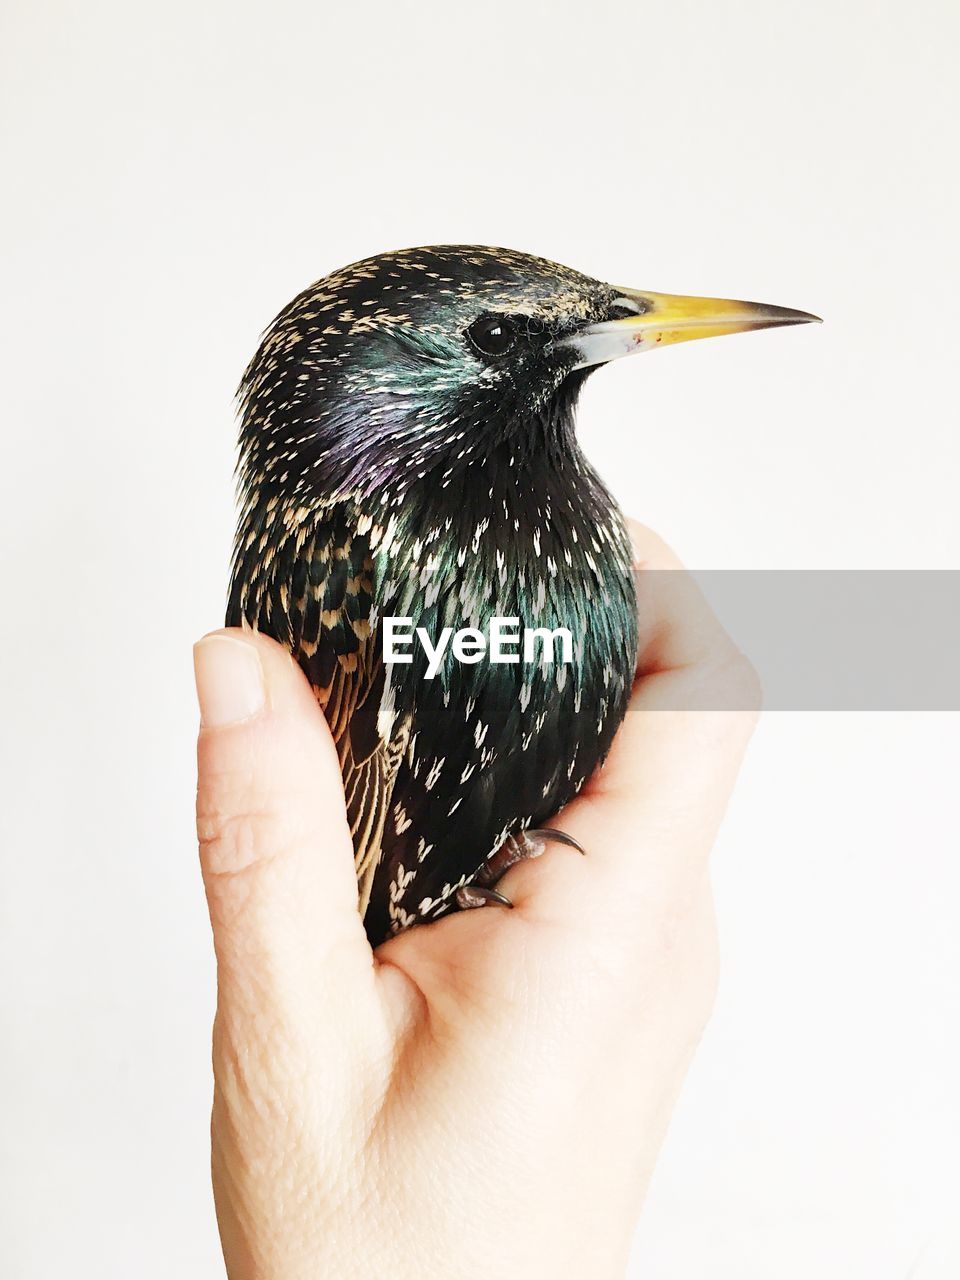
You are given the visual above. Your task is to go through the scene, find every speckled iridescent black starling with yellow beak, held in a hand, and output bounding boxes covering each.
[227,244,818,946]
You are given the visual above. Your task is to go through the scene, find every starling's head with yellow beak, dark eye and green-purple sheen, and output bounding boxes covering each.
[241,246,817,502]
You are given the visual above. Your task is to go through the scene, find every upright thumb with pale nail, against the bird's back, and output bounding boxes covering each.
[193,630,374,1025]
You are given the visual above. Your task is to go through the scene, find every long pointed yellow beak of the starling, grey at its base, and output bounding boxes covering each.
[566,288,820,369]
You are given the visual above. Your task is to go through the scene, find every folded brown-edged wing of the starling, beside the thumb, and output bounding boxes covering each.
[227,504,408,913]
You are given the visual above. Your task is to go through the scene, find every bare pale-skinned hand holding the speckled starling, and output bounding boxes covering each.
[196,514,759,1280]
